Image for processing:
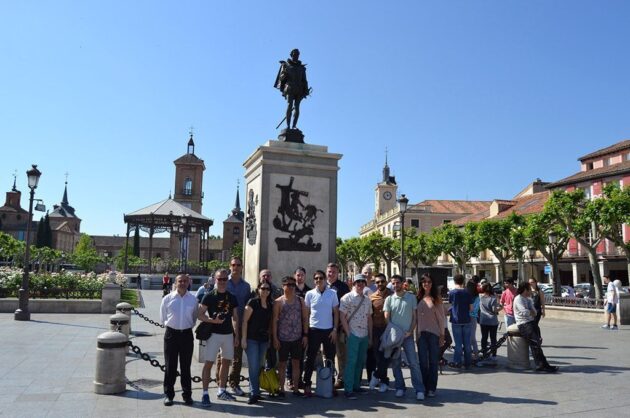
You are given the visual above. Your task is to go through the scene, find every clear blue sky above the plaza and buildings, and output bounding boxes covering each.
[0,0,630,238]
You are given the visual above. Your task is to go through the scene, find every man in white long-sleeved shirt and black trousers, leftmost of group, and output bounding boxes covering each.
[160,274,197,406]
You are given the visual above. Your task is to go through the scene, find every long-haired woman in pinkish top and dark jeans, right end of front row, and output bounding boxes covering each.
[416,273,446,398]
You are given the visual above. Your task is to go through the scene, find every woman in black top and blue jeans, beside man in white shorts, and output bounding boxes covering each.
[241,282,273,405]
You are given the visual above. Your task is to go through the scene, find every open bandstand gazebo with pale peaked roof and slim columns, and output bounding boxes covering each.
[124,197,214,273]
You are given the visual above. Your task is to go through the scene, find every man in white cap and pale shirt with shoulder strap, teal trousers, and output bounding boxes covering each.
[339,274,372,399]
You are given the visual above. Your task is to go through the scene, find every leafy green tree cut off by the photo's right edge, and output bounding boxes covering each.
[593,183,630,277]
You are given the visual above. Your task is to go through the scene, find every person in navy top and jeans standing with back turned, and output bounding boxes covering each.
[448,274,473,369]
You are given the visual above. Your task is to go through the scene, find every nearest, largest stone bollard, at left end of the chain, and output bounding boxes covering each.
[94,331,127,395]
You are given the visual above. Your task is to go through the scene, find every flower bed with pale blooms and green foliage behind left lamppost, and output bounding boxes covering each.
[0,267,127,299]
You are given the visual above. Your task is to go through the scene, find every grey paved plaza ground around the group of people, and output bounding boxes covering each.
[0,290,630,417]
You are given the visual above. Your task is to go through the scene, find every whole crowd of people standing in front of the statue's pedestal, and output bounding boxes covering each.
[160,257,556,406]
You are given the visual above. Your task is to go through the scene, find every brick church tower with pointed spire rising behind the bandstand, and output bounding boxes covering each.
[171,131,206,261]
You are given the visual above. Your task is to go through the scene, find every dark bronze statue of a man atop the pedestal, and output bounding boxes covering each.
[274,49,310,129]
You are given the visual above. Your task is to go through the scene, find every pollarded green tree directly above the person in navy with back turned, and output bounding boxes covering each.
[434,222,481,274]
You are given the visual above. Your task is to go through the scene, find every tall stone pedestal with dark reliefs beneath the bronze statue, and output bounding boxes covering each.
[243,141,341,285]
